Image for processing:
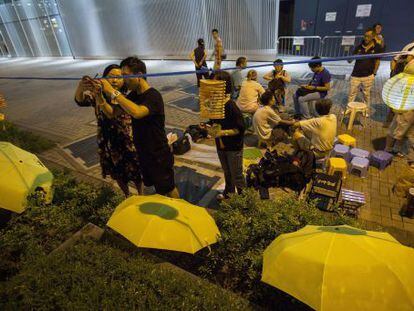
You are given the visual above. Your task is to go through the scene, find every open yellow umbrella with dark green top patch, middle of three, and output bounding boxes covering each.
[107,194,220,254]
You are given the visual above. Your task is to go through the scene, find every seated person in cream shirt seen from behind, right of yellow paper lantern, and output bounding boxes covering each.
[237,70,265,114]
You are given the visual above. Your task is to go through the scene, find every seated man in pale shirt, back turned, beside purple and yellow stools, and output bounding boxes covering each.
[293,99,337,159]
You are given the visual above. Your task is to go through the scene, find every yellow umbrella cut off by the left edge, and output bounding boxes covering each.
[0,142,53,213]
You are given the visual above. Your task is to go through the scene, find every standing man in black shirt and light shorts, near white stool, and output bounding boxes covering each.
[348,29,382,106]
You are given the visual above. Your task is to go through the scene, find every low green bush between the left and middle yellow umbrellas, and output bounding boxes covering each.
[0,171,122,281]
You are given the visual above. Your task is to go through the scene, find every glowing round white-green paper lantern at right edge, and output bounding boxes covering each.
[382,63,414,111]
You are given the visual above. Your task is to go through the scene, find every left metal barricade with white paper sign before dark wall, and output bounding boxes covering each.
[276,36,322,56]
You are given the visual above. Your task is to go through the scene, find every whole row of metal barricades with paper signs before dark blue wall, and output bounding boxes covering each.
[276,36,362,57]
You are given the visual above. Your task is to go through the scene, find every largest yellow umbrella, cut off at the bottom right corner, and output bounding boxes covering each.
[262,226,414,311]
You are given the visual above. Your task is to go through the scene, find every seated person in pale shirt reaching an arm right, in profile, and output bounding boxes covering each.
[253,90,295,145]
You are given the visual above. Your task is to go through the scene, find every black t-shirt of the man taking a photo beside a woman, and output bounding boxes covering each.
[127,88,171,160]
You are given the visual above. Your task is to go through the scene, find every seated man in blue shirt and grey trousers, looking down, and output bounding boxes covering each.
[293,56,331,119]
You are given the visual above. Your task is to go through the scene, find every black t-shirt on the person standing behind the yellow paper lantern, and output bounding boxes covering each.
[210,100,245,151]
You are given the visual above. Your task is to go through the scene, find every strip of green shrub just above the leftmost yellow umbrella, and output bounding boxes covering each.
[0,122,55,153]
